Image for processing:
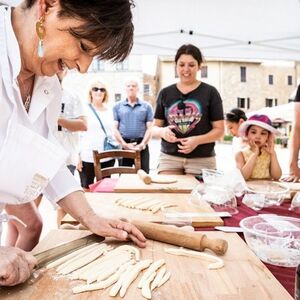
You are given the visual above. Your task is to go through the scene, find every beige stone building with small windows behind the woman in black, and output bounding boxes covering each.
[158,57,300,112]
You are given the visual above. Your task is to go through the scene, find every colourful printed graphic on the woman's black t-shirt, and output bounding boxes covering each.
[167,99,202,134]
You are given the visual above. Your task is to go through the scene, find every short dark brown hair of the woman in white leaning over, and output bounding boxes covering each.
[25,0,134,62]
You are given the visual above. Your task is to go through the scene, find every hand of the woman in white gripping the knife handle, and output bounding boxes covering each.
[0,247,37,286]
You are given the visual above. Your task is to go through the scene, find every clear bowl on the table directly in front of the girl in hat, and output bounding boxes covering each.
[246,180,289,207]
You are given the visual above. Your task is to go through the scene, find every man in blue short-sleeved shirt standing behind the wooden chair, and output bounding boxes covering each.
[113,80,153,173]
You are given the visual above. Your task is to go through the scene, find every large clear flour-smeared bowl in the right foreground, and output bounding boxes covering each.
[240,214,300,267]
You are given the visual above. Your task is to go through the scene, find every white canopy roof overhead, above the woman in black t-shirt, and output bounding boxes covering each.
[133,0,300,61]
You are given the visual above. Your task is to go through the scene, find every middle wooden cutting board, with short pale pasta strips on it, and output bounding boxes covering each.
[62,193,224,227]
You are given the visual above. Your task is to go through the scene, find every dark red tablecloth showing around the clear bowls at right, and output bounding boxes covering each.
[195,199,300,296]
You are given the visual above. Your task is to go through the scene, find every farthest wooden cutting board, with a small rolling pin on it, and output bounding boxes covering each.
[114,174,199,193]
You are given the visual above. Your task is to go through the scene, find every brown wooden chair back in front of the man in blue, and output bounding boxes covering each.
[93,150,141,181]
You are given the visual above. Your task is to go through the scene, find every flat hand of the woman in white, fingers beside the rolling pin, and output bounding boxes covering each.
[89,215,146,248]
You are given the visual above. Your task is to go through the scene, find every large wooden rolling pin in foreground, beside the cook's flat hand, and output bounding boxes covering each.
[130,220,228,255]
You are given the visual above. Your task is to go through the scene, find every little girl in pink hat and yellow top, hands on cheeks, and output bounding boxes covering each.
[235,115,282,180]
